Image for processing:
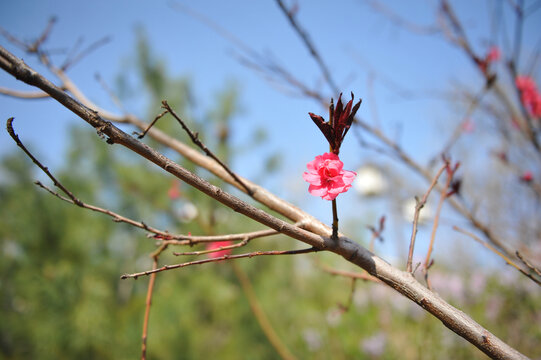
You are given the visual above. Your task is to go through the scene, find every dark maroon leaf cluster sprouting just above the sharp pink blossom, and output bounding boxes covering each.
[308,93,362,155]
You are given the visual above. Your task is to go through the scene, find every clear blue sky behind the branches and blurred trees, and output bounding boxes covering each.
[0,0,541,262]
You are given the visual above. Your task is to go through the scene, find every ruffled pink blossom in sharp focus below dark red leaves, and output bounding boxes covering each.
[302,153,357,200]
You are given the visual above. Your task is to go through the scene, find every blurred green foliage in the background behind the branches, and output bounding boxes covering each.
[0,33,541,359]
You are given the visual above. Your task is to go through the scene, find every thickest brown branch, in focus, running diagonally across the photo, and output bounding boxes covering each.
[0,47,526,359]
